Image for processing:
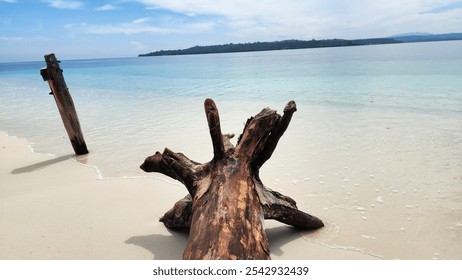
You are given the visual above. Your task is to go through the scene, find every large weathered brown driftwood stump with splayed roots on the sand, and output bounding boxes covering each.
[140,99,324,259]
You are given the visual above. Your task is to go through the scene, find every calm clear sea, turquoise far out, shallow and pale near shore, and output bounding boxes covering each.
[0,41,462,259]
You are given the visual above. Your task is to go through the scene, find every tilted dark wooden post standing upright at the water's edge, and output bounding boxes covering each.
[40,54,88,155]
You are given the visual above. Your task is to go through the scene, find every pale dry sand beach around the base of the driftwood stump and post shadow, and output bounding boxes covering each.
[0,132,377,260]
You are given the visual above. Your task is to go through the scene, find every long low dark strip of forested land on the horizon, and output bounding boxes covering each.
[138,33,462,57]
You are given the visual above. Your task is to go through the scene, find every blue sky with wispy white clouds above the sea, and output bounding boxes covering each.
[0,0,462,62]
